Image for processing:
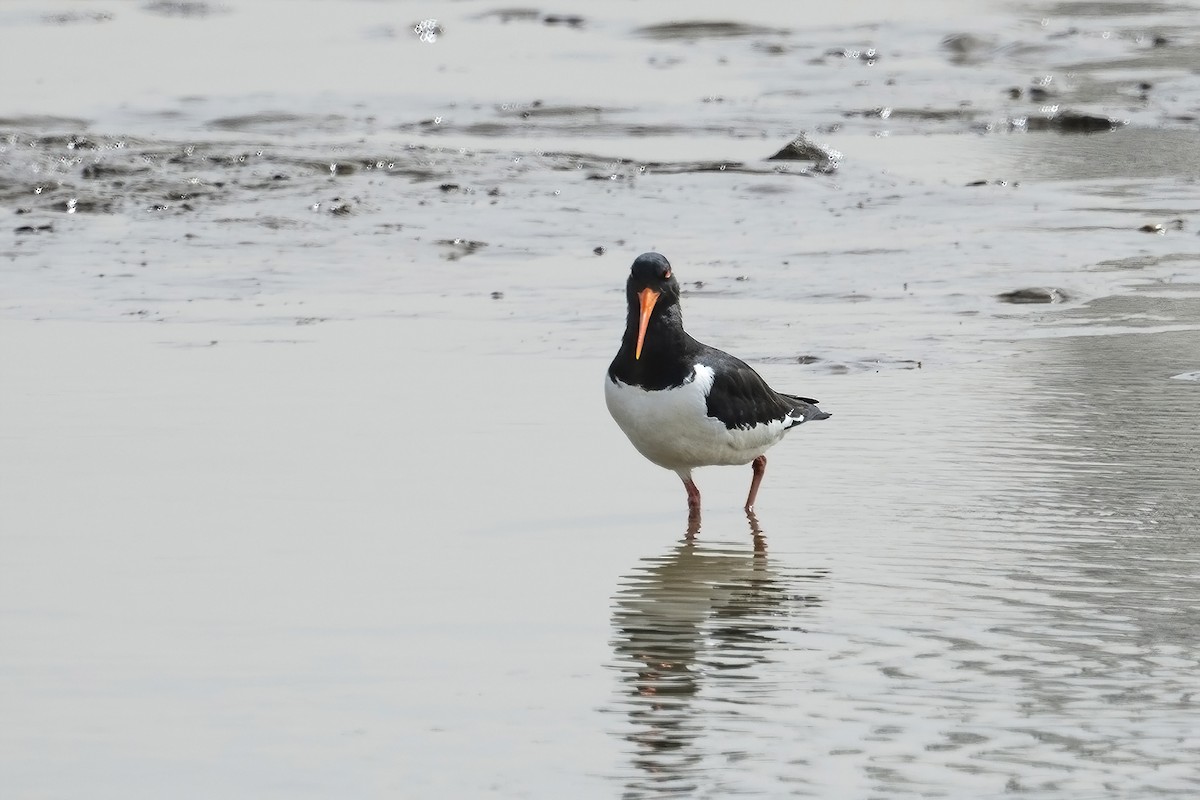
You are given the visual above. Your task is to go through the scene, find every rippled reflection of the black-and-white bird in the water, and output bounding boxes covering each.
[613,512,827,796]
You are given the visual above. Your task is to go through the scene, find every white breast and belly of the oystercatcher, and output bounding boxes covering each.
[605,363,785,471]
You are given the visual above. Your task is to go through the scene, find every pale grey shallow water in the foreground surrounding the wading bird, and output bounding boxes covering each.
[2,320,1200,796]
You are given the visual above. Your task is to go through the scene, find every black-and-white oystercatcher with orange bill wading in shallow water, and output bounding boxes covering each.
[605,253,830,519]
